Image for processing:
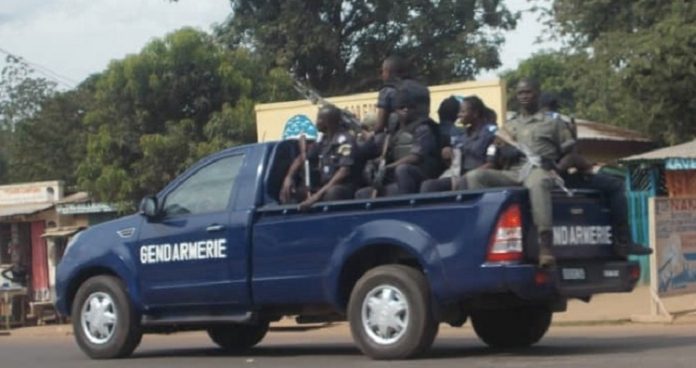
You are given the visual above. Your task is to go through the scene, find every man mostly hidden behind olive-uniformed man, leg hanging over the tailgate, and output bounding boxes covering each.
[541,93,652,258]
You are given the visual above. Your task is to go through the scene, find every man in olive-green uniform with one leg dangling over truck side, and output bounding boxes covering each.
[465,79,575,267]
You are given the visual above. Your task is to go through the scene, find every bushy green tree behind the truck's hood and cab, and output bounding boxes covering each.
[78,29,292,206]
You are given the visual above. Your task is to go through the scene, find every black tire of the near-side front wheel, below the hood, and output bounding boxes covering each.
[71,275,143,359]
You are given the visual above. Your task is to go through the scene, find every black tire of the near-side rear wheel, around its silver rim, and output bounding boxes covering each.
[348,265,439,359]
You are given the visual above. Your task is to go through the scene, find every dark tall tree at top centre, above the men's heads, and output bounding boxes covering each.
[217,0,517,94]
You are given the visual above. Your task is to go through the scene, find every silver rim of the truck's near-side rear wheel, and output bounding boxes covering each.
[362,285,409,345]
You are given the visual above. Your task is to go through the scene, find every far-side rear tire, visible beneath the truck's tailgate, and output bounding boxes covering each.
[471,307,552,348]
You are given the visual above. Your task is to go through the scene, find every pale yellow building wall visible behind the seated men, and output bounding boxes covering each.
[256,80,507,142]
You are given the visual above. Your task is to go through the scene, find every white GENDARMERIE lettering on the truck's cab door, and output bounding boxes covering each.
[140,238,227,264]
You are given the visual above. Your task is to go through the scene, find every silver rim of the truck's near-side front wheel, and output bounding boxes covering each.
[80,292,118,344]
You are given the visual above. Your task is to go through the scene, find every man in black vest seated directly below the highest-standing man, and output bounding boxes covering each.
[356,80,439,198]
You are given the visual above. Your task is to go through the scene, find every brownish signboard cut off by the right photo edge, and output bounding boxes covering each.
[650,197,696,297]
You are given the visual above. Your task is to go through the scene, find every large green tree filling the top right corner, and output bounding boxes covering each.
[537,0,696,144]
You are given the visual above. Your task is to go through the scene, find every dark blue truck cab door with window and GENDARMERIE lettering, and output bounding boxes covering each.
[134,154,249,308]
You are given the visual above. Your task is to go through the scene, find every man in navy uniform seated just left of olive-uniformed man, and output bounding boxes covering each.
[421,96,498,193]
